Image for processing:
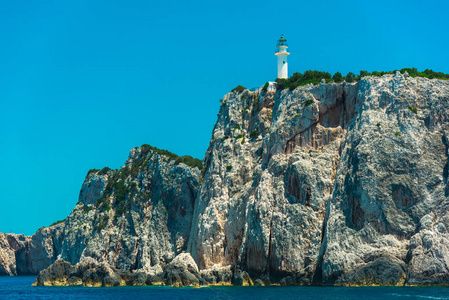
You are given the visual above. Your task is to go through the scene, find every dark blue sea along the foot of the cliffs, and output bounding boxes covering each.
[0,276,449,300]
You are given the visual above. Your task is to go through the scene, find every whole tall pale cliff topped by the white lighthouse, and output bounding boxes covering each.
[188,73,449,284]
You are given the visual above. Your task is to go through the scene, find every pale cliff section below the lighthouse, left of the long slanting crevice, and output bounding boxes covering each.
[189,76,358,283]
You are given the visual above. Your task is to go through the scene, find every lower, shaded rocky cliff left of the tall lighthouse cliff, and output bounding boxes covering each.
[0,145,201,275]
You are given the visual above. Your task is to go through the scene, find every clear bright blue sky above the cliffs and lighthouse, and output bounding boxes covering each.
[0,0,449,235]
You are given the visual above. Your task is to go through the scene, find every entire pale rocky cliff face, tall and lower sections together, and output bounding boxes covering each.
[0,73,449,285]
